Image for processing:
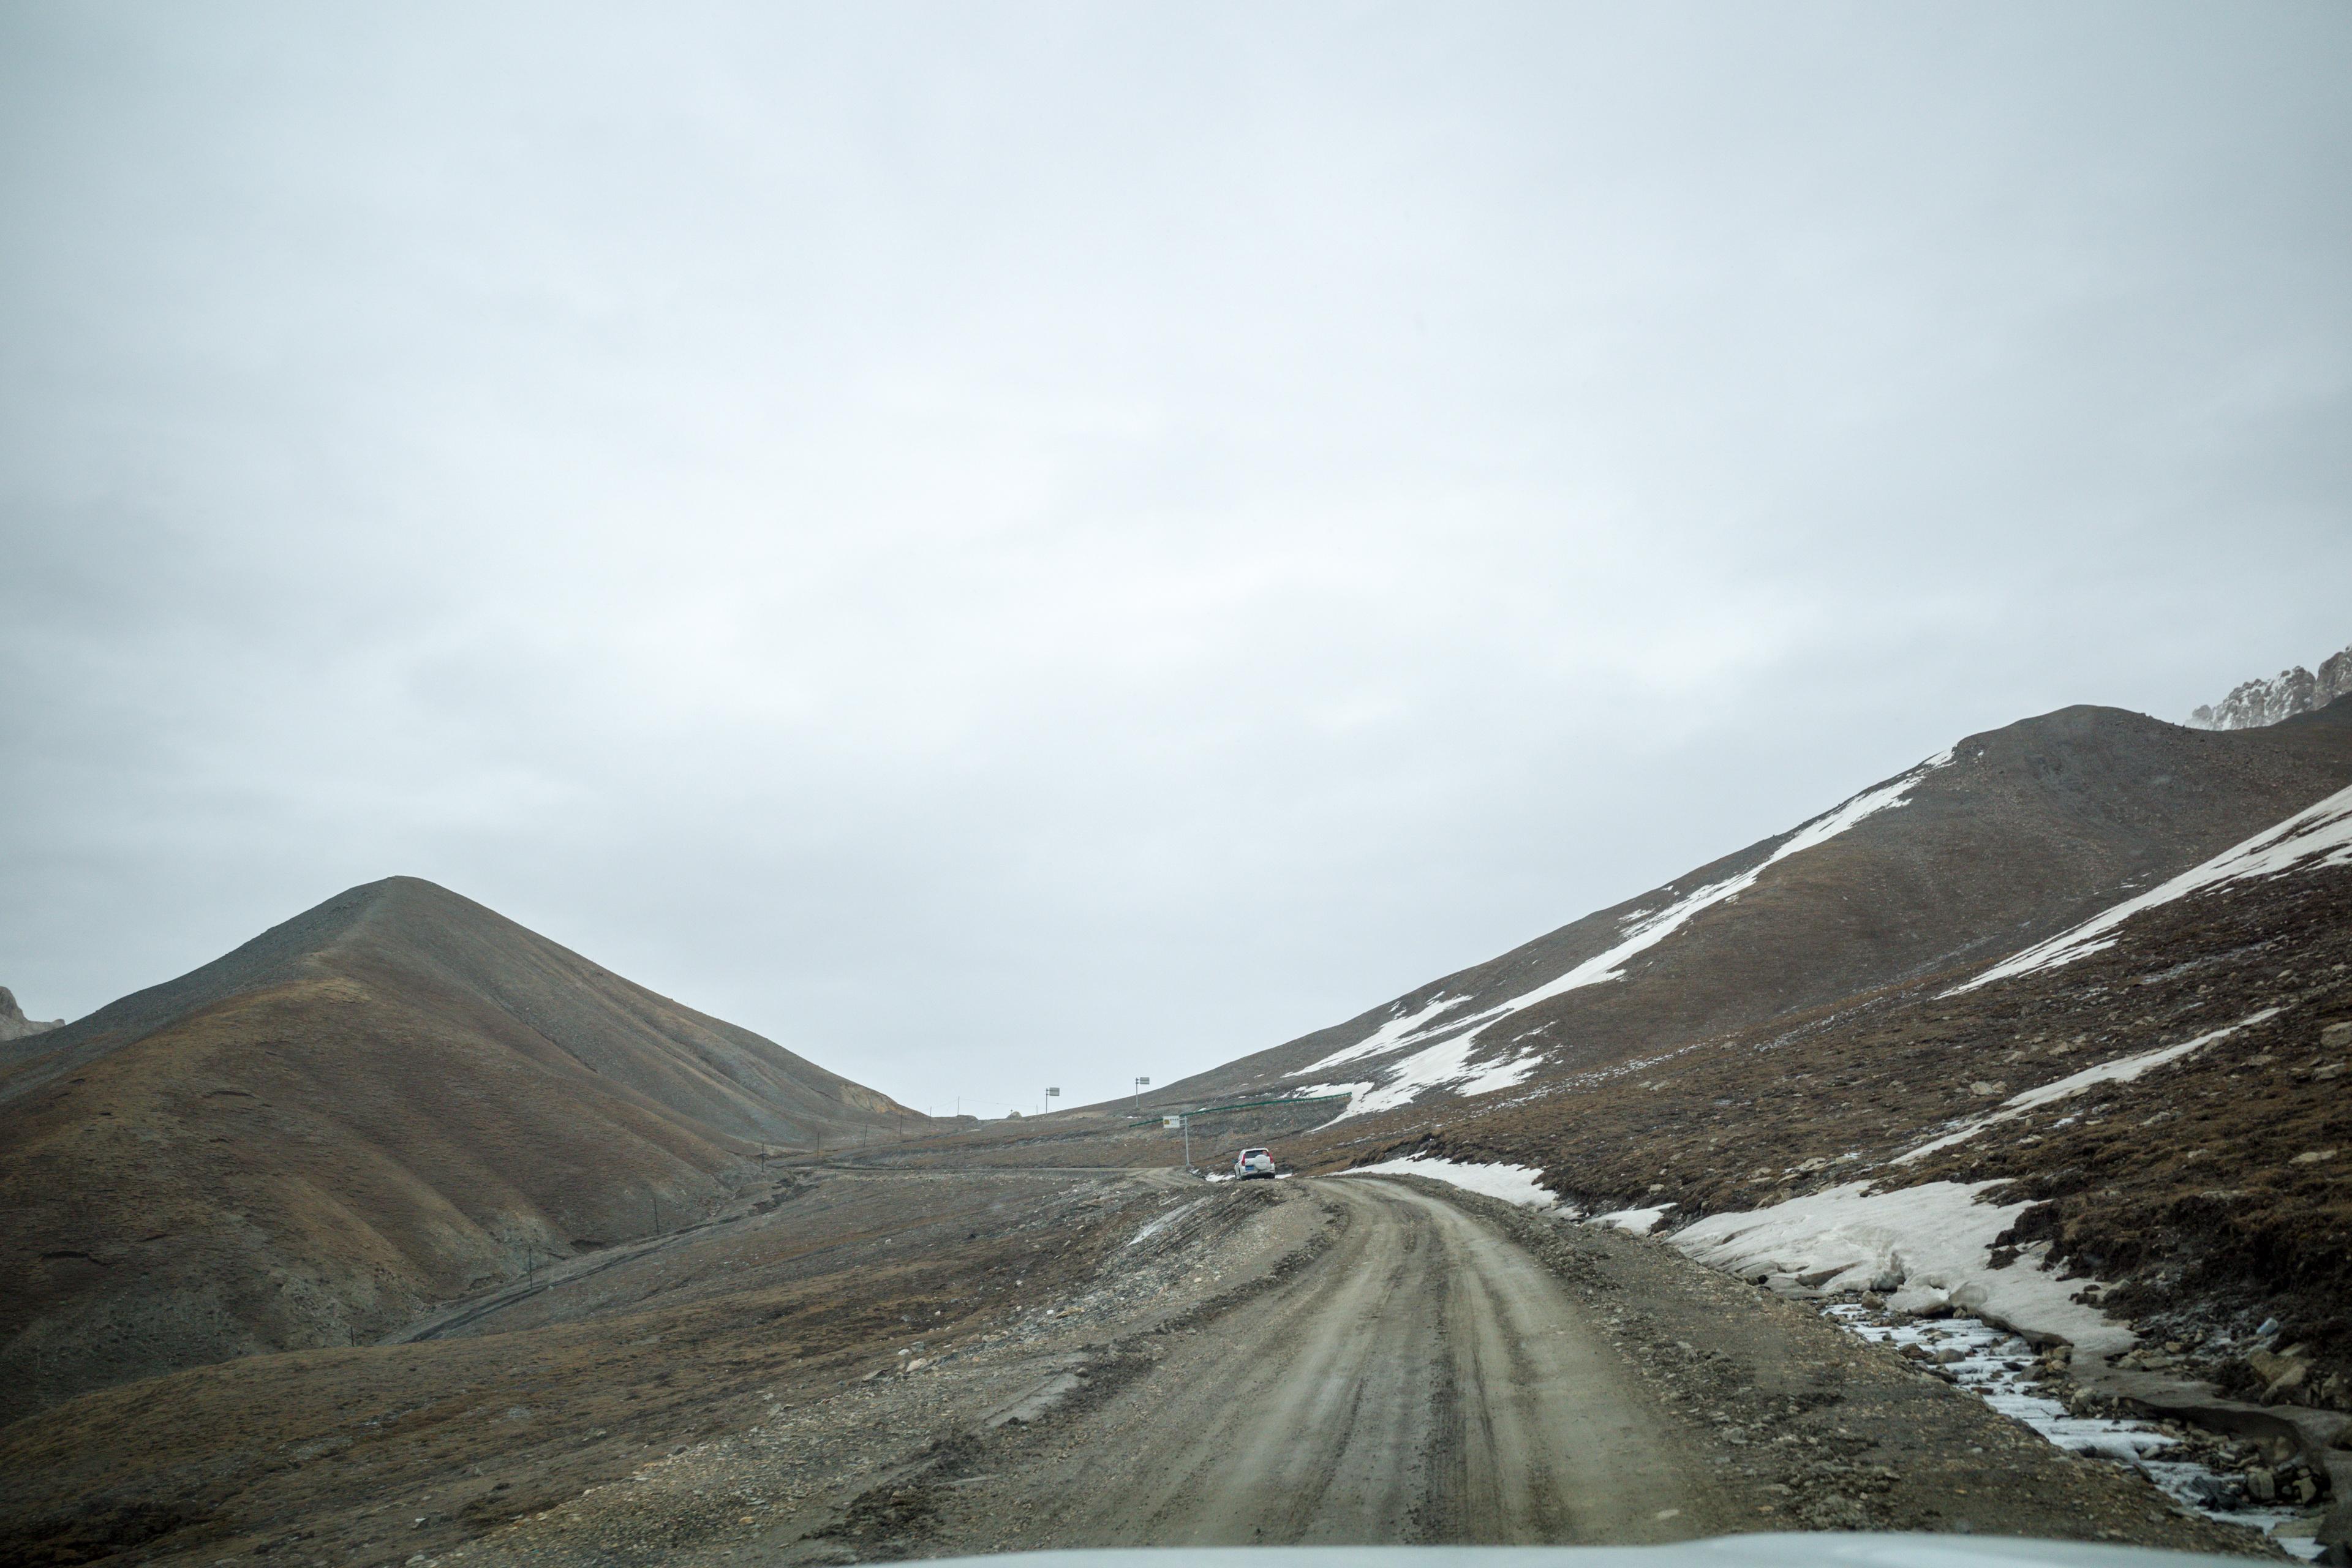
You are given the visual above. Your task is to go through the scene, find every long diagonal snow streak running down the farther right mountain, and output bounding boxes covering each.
[1301,748,1952,1119]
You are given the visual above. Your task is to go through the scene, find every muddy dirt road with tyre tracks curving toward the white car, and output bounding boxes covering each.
[983,1178,1713,1547]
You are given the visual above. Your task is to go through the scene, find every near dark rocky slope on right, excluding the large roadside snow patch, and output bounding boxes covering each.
[1284,790,2352,1363]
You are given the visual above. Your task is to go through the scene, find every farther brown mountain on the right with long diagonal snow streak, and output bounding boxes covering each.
[1155,703,2352,1119]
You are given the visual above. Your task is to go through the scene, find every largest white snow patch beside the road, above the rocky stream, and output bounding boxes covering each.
[1675,1183,2133,1357]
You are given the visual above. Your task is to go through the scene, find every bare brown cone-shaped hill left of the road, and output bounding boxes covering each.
[0,877,922,1415]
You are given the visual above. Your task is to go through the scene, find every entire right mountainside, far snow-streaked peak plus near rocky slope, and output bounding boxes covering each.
[1110,703,2352,1540]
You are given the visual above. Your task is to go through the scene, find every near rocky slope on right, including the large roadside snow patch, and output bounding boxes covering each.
[1232,705,2352,1542]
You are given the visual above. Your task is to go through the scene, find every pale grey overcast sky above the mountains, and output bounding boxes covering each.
[0,0,2352,1112]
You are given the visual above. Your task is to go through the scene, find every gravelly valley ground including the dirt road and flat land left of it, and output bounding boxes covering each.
[0,1169,2270,1568]
